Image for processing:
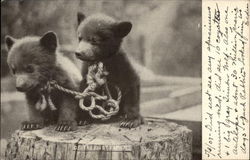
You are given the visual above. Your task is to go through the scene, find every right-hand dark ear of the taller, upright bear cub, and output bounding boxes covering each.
[114,21,132,38]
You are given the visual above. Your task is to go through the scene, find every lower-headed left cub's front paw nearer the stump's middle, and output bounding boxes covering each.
[55,120,77,132]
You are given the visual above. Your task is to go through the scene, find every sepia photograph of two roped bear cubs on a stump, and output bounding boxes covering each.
[0,0,202,160]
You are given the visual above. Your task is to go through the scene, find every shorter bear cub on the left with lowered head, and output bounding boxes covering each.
[6,32,82,131]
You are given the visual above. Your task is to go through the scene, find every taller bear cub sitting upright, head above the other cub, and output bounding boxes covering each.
[75,12,143,128]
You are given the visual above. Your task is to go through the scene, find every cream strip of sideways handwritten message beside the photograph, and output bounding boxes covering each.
[202,0,249,159]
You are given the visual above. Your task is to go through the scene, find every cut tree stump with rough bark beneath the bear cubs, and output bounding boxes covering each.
[5,119,192,160]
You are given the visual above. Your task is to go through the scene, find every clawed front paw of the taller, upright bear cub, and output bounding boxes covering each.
[120,116,144,128]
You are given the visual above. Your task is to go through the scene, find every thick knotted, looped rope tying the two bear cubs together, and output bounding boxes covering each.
[37,62,122,120]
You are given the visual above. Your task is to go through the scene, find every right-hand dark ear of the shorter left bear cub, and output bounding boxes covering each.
[40,31,57,52]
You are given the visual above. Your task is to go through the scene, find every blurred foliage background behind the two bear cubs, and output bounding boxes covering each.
[1,0,201,77]
